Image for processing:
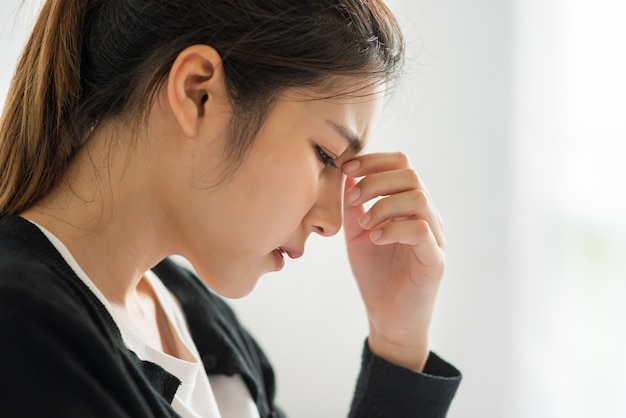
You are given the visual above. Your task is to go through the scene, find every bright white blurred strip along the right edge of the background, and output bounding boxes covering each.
[510,0,626,418]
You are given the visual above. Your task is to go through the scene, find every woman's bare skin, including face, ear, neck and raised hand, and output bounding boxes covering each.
[22,45,444,371]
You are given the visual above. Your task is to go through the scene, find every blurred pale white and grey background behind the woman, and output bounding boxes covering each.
[0,0,626,418]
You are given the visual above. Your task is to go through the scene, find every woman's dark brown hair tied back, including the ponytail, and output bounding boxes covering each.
[0,0,404,217]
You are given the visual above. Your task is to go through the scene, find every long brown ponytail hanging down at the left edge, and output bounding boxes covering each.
[0,0,89,217]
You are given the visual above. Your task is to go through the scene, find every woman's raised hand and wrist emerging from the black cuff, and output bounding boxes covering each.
[342,153,445,371]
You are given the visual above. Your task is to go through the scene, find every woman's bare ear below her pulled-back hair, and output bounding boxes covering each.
[167,45,226,138]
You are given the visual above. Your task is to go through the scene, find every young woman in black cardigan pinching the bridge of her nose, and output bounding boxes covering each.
[0,0,460,418]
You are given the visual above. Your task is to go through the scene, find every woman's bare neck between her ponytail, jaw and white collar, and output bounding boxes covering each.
[21,124,171,305]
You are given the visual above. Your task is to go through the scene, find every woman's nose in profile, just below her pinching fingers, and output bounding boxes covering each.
[304,173,344,237]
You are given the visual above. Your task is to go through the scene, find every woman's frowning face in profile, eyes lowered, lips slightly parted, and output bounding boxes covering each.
[177,81,384,297]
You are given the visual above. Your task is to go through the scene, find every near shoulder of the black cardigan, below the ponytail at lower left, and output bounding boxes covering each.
[0,217,167,417]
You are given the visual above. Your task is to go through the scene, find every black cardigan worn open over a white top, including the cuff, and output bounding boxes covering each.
[0,216,461,418]
